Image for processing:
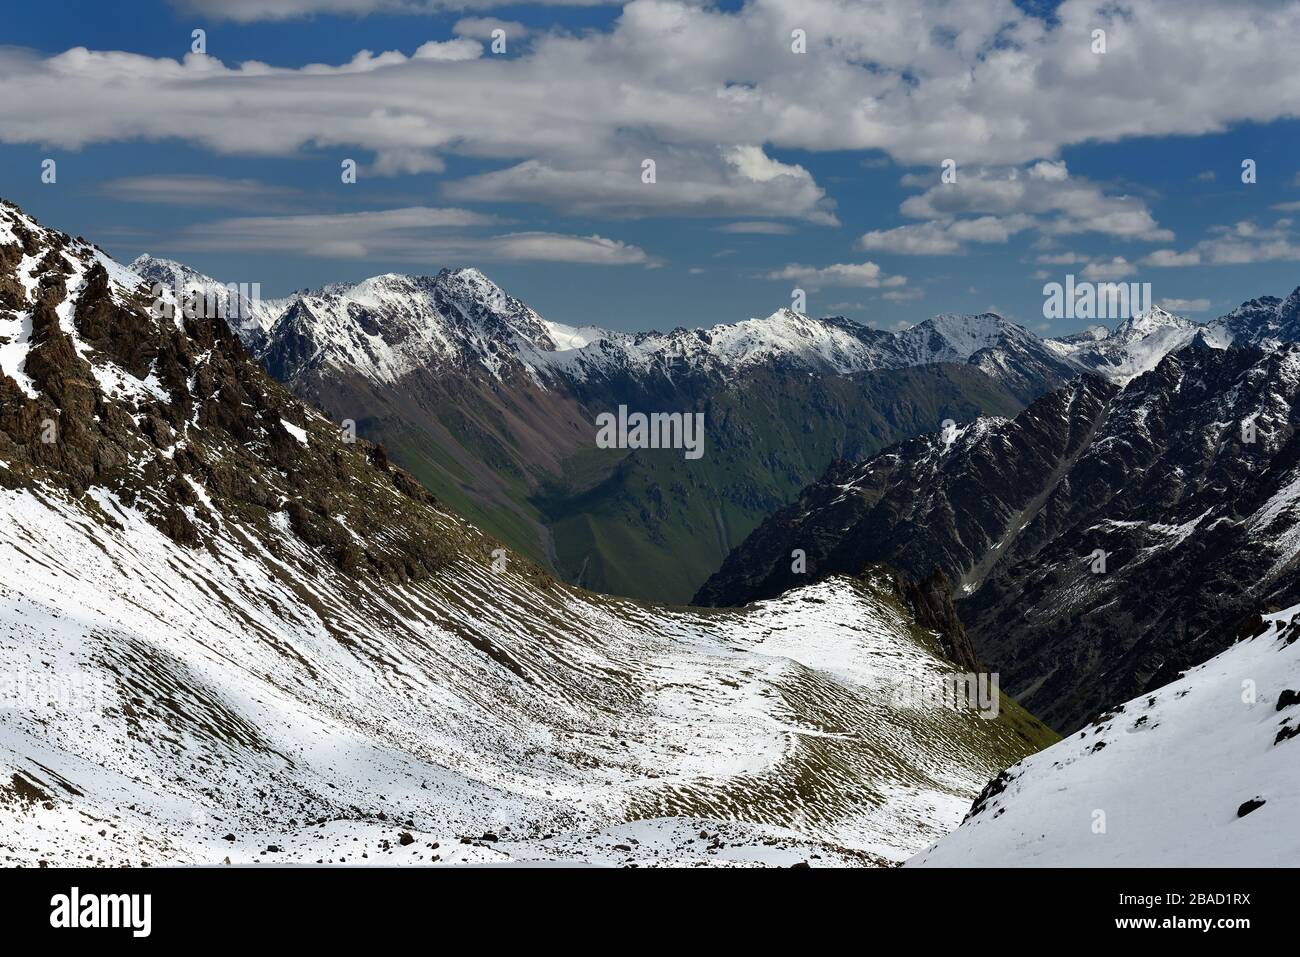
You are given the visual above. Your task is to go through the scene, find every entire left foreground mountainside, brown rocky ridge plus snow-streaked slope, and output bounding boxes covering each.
[0,204,1053,866]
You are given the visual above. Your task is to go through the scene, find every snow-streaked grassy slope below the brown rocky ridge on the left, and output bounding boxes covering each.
[0,490,1040,865]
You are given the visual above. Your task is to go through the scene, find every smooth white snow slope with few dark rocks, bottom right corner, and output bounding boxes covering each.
[910,606,1300,867]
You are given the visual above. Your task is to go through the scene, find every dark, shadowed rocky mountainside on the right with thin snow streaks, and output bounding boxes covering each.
[697,332,1300,729]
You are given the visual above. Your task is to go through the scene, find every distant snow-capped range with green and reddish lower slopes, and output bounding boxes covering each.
[124,260,1074,602]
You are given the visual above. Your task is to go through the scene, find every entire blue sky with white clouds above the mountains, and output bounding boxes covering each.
[0,0,1300,334]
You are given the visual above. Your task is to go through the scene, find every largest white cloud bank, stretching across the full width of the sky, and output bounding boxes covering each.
[0,0,1300,223]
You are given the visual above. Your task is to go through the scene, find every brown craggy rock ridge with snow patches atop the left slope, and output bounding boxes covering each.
[0,197,491,581]
